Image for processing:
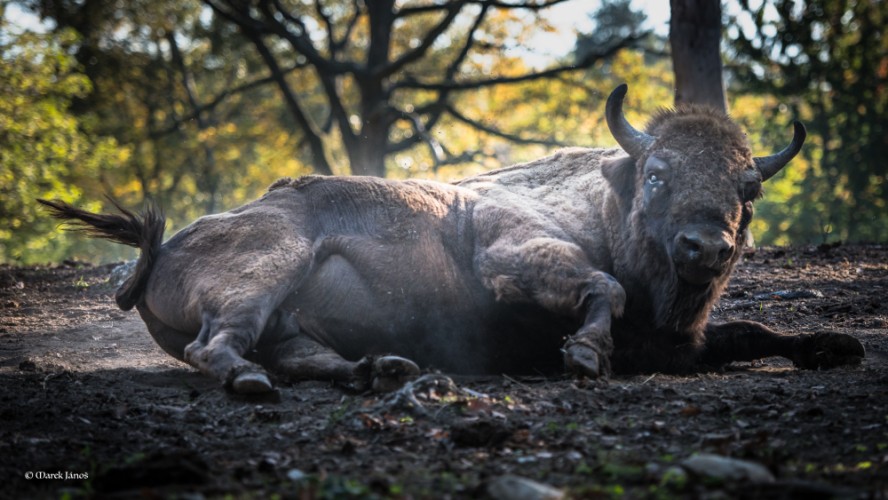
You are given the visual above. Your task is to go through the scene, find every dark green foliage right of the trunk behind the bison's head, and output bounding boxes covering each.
[727,0,888,244]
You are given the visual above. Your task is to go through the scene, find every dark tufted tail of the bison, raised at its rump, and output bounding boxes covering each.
[37,198,166,311]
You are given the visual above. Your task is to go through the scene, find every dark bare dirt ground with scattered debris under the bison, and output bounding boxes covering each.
[0,246,888,498]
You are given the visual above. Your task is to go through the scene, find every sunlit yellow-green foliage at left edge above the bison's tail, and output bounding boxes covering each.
[0,17,125,263]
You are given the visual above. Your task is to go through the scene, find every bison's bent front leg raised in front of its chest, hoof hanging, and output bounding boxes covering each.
[479,237,626,378]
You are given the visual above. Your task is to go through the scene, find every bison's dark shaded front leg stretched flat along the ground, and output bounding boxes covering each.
[700,321,866,370]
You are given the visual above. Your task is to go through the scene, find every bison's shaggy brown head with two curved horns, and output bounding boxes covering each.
[603,84,805,286]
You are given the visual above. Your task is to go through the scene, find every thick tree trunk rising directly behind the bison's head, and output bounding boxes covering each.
[669,0,727,111]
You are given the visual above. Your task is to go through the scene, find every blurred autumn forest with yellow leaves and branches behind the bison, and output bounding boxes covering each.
[0,0,888,264]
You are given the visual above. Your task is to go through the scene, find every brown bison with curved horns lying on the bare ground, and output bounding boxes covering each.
[40,85,864,393]
